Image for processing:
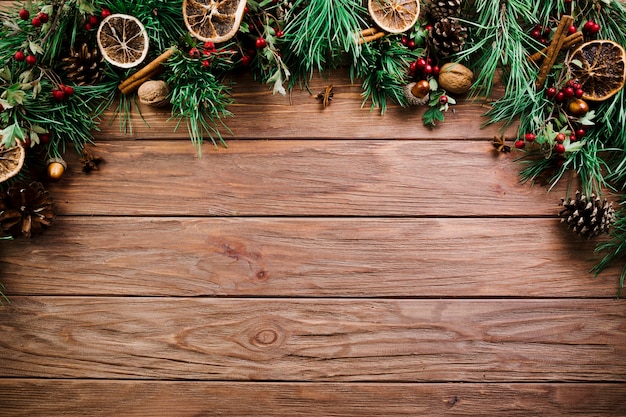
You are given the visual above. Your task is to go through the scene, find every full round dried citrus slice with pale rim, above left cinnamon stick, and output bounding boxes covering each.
[97,13,148,68]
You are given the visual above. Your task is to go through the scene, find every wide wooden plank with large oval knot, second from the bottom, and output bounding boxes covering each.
[0,297,626,383]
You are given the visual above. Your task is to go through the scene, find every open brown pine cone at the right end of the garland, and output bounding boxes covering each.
[559,191,615,239]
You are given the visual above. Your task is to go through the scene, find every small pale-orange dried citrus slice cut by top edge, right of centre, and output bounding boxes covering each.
[367,0,420,33]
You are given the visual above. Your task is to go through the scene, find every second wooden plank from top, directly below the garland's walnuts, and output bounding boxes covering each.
[50,141,565,217]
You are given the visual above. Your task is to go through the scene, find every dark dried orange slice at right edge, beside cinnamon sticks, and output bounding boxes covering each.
[567,40,626,101]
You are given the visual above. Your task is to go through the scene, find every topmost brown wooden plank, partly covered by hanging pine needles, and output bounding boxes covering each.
[96,69,516,140]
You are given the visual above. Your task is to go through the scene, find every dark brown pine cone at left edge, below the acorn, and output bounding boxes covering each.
[0,181,54,237]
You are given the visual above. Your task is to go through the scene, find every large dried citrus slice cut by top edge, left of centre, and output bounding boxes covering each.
[183,0,246,43]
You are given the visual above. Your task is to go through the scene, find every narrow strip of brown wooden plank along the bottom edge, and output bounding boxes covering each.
[0,379,626,417]
